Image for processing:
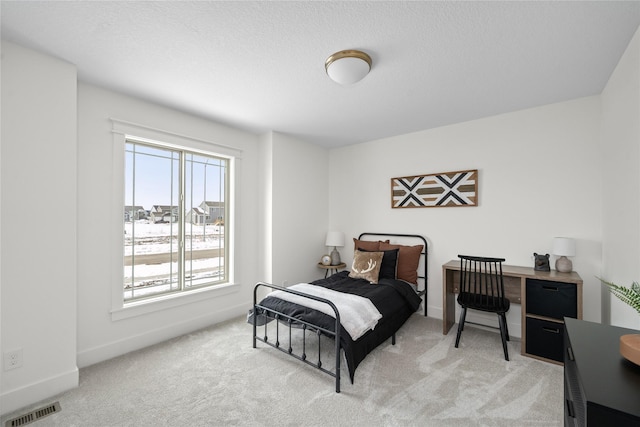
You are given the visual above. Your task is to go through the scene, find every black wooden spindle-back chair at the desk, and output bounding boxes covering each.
[456,255,511,360]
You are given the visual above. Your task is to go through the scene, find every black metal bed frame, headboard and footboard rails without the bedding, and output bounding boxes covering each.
[252,233,428,393]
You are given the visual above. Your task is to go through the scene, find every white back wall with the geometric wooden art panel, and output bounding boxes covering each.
[329,97,602,336]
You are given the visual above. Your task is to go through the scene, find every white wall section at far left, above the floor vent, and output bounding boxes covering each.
[0,41,78,413]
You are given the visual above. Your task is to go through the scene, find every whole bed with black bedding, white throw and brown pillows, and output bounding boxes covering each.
[248,233,428,393]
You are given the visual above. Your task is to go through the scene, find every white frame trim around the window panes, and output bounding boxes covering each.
[110,118,242,320]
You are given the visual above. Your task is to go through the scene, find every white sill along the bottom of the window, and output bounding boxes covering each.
[111,283,240,322]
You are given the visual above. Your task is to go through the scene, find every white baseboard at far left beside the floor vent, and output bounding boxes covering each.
[0,367,79,415]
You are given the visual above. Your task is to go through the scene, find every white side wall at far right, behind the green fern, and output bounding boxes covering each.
[601,26,640,329]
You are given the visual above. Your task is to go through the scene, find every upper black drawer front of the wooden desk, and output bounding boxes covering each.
[527,279,578,319]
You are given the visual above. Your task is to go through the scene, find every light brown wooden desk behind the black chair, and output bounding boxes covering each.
[442,260,582,364]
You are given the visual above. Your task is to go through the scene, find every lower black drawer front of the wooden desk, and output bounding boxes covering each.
[526,317,564,362]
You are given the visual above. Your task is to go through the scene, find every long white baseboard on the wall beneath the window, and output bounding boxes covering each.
[77,304,248,368]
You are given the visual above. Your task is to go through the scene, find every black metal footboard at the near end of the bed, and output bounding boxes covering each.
[252,282,342,393]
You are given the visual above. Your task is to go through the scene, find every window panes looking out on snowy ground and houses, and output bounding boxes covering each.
[123,137,230,303]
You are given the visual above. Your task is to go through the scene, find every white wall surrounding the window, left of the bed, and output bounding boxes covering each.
[77,83,260,367]
